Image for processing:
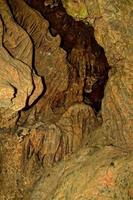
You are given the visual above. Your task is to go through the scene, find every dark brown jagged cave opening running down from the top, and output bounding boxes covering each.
[27,0,110,113]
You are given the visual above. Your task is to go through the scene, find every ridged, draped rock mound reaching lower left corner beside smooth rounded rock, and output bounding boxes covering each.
[0,104,98,200]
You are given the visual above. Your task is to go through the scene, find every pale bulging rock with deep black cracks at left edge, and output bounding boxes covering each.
[0,0,43,128]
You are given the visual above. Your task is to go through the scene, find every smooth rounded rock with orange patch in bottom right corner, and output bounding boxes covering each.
[29,147,133,200]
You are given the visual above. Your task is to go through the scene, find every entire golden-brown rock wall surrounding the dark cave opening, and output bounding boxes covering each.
[0,0,133,200]
